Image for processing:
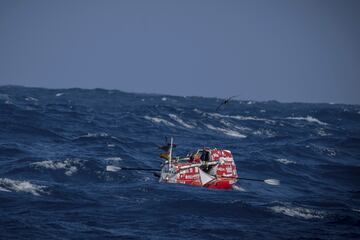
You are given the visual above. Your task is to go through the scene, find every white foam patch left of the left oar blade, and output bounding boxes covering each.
[31,159,83,176]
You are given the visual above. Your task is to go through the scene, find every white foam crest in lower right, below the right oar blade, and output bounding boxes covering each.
[270,206,325,219]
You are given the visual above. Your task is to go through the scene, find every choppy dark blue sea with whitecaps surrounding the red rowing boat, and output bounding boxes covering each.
[0,86,360,239]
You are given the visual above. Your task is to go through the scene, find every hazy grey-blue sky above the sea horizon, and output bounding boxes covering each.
[0,0,360,104]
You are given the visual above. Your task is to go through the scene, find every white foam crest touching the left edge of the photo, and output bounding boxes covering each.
[0,178,46,196]
